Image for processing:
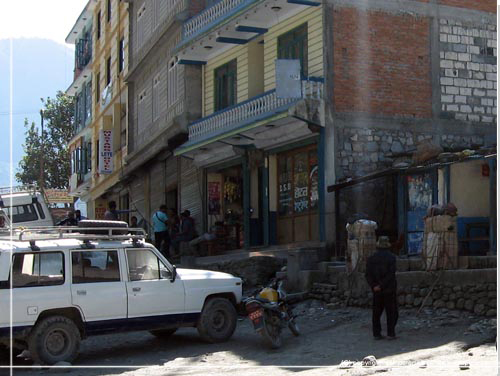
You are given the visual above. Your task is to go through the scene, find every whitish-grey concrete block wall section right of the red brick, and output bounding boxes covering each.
[439,18,497,122]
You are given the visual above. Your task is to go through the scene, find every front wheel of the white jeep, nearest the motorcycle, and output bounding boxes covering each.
[197,298,237,343]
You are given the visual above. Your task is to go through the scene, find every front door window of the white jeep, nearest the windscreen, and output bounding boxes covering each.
[127,249,171,281]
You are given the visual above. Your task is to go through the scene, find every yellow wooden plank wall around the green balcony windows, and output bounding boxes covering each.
[203,7,323,116]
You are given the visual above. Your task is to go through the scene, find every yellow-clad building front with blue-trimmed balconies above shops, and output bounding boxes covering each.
[176,0,325,248]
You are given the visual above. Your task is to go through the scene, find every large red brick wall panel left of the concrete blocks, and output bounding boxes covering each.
[333,7,432,118]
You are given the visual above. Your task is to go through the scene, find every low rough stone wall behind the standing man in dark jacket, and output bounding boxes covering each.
[309,282,497,316]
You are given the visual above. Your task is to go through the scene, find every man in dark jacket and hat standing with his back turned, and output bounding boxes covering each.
[365,236,398,339]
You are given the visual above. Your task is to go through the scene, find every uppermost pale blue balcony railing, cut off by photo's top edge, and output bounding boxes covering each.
[182,0,256,39]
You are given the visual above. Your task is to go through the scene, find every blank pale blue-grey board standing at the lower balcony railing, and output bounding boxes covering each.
[275,59,302,98]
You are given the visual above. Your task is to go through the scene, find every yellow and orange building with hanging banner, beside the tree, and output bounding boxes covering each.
[67,0,128,218]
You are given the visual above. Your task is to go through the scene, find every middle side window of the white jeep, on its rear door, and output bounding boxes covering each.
[71,251,120,283]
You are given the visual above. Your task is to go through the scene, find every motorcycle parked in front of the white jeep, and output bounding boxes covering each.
[243,279,300,349]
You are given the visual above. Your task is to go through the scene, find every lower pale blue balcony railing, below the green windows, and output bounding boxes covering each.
[188,77,323,142]
